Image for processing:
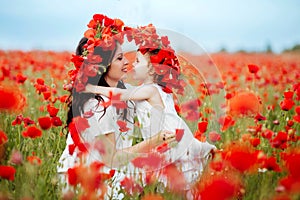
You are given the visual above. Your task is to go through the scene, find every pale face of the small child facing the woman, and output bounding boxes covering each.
[132,51,150,81]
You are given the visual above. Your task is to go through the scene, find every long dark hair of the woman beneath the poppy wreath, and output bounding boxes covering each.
[67,37,127,126]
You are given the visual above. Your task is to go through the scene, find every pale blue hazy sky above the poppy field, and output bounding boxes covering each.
[0,0,300,53]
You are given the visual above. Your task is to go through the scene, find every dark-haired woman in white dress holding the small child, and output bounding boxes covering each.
[58,16,175,197]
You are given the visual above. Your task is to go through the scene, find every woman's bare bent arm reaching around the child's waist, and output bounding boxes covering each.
[98,131,176,168]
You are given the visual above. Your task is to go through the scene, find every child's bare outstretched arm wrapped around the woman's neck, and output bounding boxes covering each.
[85,84,155,101]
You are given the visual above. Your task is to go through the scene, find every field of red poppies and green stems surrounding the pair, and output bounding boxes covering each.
[0,50,300,200]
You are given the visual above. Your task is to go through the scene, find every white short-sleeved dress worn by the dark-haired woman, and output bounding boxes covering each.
[57,96,133,199]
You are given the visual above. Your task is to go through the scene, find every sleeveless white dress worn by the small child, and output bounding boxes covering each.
[135,84,216,189]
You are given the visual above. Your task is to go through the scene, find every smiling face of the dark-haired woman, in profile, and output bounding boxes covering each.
[105,44,128,86]
